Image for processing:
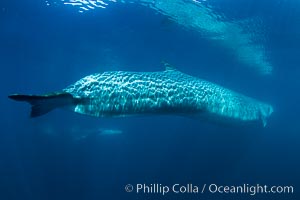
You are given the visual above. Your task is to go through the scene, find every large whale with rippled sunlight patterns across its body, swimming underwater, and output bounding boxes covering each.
[9,67,273,126]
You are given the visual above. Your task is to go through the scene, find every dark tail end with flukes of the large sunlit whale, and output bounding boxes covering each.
[8,92,80,117]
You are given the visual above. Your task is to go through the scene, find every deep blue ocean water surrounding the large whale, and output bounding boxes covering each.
[0,0,300,200]
